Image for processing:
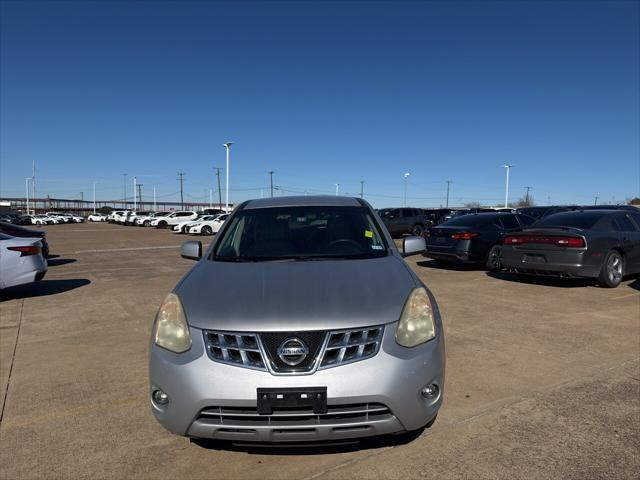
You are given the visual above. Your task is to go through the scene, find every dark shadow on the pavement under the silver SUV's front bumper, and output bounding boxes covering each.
[190,429,423,455]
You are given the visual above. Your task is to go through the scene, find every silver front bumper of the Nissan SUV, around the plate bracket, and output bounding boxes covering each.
[149,323,445,442]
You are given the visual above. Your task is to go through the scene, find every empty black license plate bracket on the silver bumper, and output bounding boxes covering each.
[257,387,327,415]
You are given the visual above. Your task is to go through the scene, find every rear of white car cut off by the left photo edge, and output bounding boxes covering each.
[0,233,47,290]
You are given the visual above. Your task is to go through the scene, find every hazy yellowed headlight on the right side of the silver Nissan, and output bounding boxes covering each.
[396,287,436,347]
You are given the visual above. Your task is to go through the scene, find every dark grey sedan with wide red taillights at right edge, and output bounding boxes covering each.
[502,209,640,288]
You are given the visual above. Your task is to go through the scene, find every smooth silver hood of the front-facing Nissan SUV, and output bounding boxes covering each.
[176,256,416,332]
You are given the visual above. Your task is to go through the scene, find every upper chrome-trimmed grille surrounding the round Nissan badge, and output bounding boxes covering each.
[203,325,384,375]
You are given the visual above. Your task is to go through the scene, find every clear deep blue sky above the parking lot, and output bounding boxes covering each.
[0,1,640,207]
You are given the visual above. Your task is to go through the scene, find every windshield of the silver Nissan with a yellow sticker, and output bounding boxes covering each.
[213,206,387,261]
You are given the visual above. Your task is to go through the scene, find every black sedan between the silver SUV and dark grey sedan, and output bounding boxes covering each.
[423,213,534,270]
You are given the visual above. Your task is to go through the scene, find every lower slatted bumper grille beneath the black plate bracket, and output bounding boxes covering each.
[198,403,392,428]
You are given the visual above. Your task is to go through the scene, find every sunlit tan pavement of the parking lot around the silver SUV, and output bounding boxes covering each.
[0,224,640,479]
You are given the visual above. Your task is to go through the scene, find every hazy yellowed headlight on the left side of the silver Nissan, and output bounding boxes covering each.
[153,293,191,353]
